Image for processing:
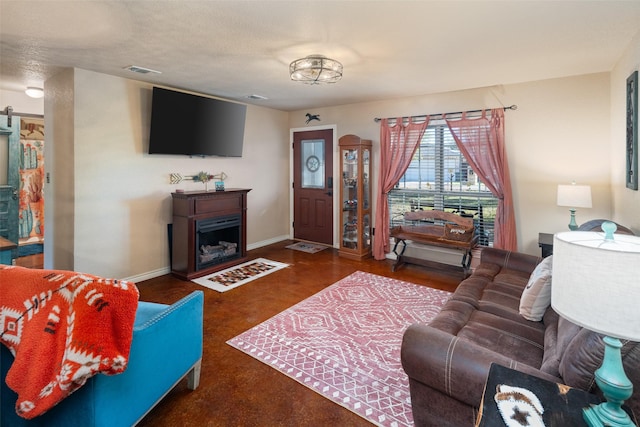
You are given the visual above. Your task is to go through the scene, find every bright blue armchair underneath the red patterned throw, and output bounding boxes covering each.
[0,291,204,427]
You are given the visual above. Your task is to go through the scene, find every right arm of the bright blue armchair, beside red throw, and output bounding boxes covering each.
[93,290,204,426]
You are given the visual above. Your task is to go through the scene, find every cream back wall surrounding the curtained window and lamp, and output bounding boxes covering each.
[289,73,612,255]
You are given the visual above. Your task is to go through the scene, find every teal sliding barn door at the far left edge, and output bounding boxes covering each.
[0,115,20,259]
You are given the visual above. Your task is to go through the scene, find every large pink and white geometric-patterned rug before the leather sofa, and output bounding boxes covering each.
[227,271,451,426]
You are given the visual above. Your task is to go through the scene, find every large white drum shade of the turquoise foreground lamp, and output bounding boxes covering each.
[551,231,640,341]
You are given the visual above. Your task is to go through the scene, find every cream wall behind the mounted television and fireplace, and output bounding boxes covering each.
[45,69,289,280]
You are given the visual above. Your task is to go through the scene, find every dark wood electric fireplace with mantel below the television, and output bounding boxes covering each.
[171,189,251,280]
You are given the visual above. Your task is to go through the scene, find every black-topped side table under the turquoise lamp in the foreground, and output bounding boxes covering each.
[476,363,637,427]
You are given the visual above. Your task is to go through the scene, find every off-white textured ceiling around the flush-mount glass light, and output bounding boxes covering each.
[0,0,640,110]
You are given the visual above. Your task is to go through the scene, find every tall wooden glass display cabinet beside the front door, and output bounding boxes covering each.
[338,135,372,260]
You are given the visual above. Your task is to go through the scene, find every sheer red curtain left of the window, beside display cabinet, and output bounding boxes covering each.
[373,116,429,260]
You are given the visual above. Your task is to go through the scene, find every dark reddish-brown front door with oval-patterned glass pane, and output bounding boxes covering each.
[293,129,333,245]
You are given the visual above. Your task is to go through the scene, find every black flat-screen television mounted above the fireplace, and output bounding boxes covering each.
[149,87,247,157]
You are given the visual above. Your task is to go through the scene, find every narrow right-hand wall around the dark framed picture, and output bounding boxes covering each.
[610,32,640,234]
